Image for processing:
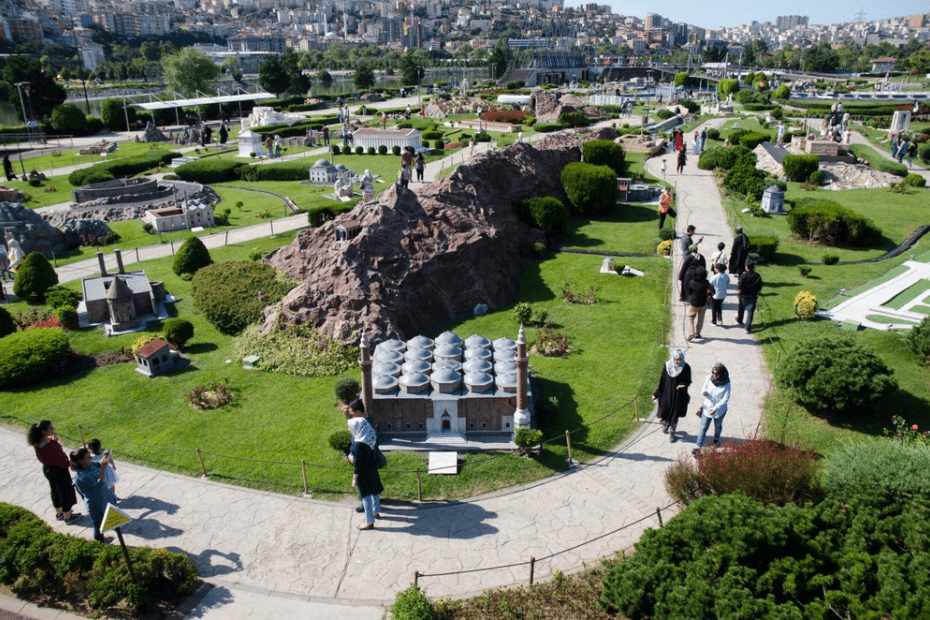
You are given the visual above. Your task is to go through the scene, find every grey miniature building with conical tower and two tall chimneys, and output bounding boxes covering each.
[81,250,165,331]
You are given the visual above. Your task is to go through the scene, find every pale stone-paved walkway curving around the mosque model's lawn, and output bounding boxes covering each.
[0,116,768,620]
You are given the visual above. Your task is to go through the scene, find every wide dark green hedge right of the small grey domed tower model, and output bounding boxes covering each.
[788,202,882,246]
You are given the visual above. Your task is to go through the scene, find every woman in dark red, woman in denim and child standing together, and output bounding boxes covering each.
[26,420,117,542]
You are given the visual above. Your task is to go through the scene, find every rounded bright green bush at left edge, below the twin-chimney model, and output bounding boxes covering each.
[0,327,70,389]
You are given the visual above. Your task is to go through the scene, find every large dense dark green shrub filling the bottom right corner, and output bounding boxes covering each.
[600,493,930,620]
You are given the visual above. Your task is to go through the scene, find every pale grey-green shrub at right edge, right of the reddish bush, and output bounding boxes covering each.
[823,439,930,505]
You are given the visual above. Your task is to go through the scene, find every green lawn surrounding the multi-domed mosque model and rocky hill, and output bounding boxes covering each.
[0,205,669,499]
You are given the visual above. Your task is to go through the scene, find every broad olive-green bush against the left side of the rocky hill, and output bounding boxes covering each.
[191,261,291,334]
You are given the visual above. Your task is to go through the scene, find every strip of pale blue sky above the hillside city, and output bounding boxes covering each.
[565,0,930,28]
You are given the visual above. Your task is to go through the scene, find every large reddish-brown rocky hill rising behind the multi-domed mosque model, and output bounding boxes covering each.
[263,129,617,342]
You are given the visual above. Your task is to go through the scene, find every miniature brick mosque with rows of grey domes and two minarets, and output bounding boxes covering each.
[359,327,532,444]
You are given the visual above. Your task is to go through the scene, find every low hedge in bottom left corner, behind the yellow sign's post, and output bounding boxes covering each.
[0,504,197,614]
